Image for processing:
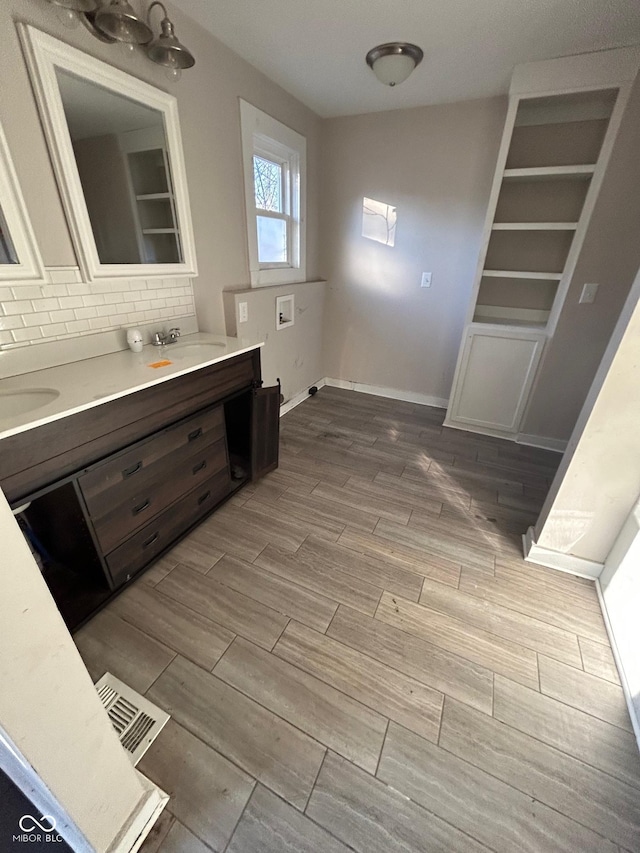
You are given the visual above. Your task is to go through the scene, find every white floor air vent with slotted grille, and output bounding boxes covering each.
[96,672,169,765]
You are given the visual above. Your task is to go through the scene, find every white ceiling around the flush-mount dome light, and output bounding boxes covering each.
[172,0,640,117]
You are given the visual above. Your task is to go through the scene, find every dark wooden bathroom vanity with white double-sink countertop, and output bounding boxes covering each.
[0,335,280,629]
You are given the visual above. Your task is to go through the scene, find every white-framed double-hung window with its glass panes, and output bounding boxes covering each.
[240,100,306,287]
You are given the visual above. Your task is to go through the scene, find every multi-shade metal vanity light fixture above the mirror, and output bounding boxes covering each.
[49,0,196,80]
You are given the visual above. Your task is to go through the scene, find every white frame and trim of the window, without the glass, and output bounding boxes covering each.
[240,99,307,287]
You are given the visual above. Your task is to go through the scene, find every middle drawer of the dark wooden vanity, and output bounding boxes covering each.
[93,438,230,554]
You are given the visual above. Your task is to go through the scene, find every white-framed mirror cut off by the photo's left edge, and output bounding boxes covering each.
[0,125,44,285]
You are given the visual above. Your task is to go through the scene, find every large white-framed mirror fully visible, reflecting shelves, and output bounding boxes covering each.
[18,24,197,280]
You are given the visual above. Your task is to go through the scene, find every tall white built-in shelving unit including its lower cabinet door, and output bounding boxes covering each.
[445,48,640,437]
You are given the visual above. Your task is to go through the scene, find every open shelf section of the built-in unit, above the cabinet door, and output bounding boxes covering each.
[473,89,617,328]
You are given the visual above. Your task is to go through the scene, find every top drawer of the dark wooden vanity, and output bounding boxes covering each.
[78,406,225,510]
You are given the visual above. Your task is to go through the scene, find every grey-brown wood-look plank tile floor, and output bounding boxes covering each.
[76,388,640,853]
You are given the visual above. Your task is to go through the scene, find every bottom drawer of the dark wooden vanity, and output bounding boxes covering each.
[106,470,231,588]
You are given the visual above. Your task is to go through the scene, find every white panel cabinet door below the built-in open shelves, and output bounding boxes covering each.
[445,328,545,433]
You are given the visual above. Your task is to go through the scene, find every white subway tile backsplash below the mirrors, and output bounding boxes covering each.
[0,267,195,347]
